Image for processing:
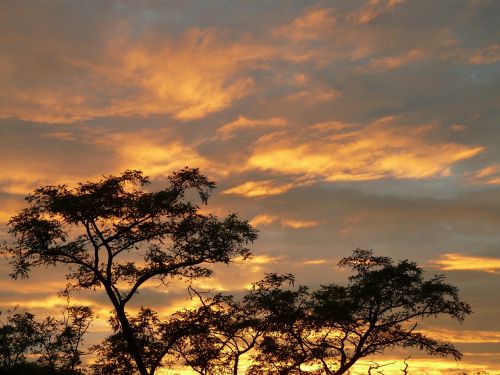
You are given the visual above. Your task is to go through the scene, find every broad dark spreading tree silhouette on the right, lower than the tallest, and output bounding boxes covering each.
[249,249,471,375]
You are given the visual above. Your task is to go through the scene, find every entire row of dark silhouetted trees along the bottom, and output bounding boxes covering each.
[0,168,471,375]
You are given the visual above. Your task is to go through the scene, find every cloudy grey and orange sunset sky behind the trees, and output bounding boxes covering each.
[0,0,500,374]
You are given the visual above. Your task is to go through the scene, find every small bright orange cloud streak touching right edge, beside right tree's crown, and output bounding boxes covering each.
[431,253,500,273]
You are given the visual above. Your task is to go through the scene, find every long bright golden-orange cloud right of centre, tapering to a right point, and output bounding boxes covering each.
[247,117,484,181]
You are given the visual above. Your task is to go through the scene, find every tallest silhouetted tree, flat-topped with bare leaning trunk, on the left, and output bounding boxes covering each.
[8,168,257,375]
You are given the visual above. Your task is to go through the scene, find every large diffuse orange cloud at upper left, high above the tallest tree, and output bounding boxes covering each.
[0,27,270,123]
